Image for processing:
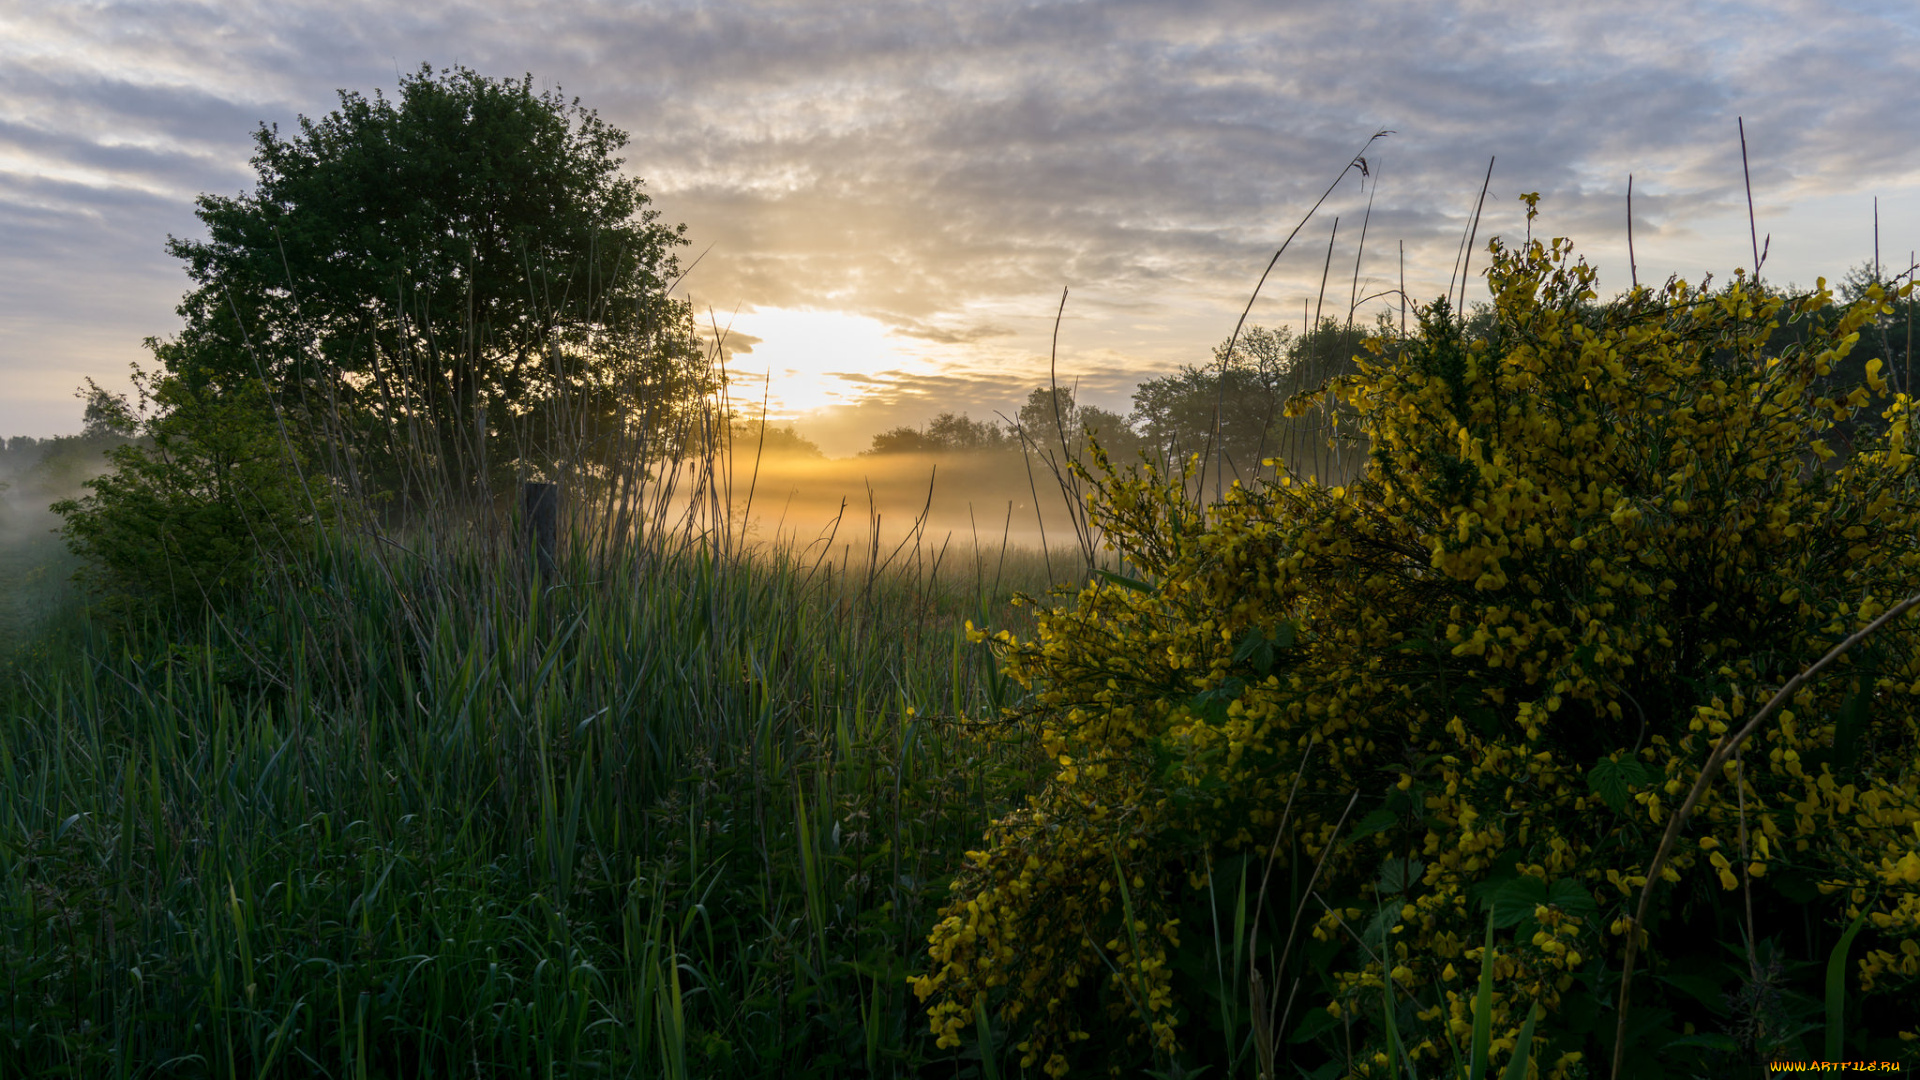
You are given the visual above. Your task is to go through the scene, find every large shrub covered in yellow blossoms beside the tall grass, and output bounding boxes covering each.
[914,199,1920,1076]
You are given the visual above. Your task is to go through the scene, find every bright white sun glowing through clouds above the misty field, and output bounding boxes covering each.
[720,307,922,419]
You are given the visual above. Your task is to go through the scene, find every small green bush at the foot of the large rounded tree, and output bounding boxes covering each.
[52,361,328,617]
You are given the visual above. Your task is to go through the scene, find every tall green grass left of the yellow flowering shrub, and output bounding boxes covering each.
[0,476,1105,1078]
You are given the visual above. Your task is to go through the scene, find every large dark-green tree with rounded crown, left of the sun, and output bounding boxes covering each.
[157,65,707,507]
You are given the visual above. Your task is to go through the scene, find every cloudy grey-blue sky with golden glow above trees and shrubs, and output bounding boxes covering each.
[0,0,1920,454]
